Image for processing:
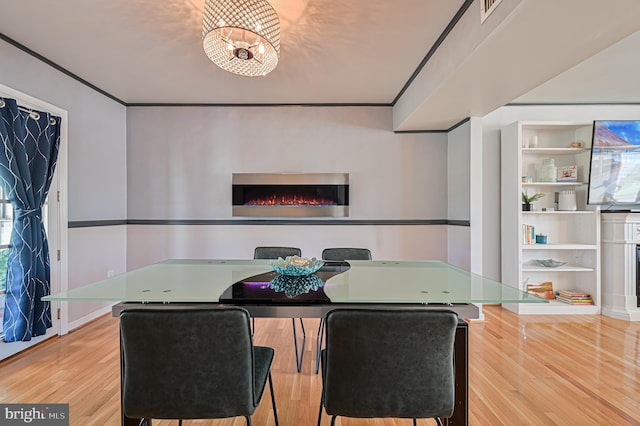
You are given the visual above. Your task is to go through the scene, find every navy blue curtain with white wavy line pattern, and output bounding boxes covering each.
[0,97,60,342]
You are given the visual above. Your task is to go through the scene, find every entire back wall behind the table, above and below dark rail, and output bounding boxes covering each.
[127,107,447,268]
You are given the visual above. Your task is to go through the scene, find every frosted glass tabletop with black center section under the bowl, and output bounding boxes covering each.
[43,259,548,304]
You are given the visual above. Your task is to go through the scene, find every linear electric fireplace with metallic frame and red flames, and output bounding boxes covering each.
[232,173,349,217]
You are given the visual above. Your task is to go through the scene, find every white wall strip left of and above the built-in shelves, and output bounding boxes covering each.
[482,105,640,280]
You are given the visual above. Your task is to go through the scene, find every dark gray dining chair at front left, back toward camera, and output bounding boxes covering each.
[120,307,278,426]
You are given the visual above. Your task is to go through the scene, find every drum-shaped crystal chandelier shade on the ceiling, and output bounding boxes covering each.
[202,0,280,76]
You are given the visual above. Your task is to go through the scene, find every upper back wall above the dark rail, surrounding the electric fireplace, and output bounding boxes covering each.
[127,107,447,219]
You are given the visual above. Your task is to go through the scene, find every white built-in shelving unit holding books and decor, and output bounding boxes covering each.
[501,122,601,314]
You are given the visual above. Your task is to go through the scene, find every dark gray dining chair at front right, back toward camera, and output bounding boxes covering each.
[318,309,458,426]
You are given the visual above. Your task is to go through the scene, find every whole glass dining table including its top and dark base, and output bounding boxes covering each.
[44,259,548,425]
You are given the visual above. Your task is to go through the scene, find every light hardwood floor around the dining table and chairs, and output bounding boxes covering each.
[0,306,640,426]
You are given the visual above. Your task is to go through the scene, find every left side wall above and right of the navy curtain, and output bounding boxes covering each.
[0,41,127,322]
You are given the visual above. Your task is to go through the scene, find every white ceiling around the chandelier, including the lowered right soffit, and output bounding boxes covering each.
[0,0,640,130]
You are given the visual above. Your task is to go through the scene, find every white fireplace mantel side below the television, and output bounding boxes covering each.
[602,213,640,321]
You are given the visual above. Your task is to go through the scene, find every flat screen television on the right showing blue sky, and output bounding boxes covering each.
[587,120,640,210]
